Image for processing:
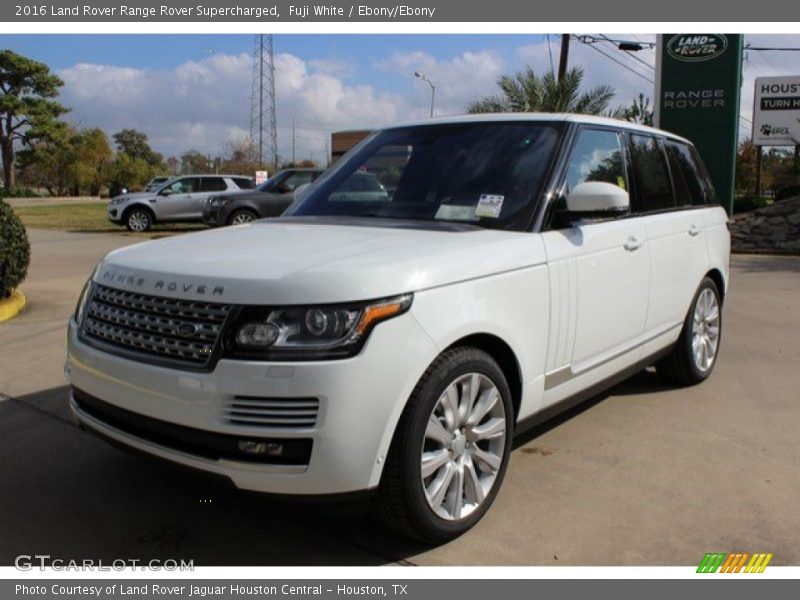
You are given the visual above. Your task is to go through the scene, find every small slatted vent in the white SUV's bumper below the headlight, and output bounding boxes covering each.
[223,396,319,429]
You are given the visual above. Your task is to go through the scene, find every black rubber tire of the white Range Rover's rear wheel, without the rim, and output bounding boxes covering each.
[656,277,722,385]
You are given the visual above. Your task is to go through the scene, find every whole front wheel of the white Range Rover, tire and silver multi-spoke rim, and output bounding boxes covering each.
[375,347,514,543]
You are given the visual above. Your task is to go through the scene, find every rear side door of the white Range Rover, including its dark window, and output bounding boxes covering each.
[630,133,708,351]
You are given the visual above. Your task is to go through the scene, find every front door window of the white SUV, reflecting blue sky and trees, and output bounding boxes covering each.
[567,129,628,193]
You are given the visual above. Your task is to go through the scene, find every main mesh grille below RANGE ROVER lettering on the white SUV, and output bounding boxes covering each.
[81,285,231,368]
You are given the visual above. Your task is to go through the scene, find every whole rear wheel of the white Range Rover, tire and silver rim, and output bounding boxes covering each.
[656,277,722,385]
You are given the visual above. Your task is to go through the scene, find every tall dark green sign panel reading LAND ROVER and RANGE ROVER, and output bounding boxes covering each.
[655,33,743,214]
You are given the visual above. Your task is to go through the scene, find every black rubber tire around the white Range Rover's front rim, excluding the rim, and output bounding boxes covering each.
[372,347,514,543]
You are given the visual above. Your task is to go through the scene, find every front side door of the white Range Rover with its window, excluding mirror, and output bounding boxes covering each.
[543,127,650,405]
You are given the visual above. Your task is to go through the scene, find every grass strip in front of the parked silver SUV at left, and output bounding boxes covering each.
[14,203,206,236]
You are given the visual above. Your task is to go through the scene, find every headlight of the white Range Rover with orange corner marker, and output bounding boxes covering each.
[225,294,413,360]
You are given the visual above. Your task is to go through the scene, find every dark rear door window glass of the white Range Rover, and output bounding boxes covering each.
[631,134,675,213]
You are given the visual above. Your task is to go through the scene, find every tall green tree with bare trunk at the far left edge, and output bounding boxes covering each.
[0,50,67,188]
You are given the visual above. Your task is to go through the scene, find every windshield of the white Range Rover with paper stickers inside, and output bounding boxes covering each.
[285,121,559,230]
